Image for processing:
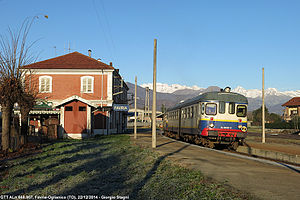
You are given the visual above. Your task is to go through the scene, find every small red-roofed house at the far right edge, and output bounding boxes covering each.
[282,97,300,121]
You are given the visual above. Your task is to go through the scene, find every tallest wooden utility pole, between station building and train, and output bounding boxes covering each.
[152,39,157,148]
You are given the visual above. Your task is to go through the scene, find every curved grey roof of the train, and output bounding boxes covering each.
[168,91,248,111]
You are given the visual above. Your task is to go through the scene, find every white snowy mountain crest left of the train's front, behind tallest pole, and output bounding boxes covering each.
[140,83,204,93]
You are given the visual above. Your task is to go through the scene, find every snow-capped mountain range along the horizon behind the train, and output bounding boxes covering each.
[132,83,300,115]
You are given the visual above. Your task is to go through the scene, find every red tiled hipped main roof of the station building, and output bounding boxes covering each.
[23,51,115,69]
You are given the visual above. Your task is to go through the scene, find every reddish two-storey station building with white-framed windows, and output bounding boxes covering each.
[23,52,128,138]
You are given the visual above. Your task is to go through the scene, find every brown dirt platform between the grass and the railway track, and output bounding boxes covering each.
[132,133,300,200]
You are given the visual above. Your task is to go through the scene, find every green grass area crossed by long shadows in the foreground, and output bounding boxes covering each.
[0,135,250,199]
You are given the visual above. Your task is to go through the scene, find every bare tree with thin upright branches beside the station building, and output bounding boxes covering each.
[0,16,48,150]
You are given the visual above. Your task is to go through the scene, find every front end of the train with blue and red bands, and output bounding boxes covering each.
[199,88,248,149]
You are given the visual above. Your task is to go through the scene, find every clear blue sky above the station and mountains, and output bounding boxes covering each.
[0,0,300,91]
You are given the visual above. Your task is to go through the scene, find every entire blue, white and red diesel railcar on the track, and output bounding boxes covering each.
[164,87,248,150]
